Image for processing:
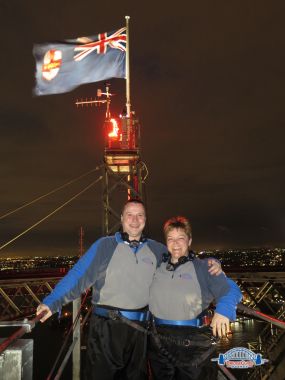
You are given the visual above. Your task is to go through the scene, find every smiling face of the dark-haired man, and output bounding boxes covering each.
[121,202,146,240]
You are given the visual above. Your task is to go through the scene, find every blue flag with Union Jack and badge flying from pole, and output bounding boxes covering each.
[33,28,126,95]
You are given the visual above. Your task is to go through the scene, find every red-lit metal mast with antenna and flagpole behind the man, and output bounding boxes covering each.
[76,16,147,235]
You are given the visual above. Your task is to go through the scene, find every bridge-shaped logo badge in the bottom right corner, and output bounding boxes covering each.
[211,347,268,368]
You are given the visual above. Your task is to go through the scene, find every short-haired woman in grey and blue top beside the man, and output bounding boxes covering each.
[149,216,241,380]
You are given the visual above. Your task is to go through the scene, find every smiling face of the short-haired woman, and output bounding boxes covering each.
[166,228,192,263]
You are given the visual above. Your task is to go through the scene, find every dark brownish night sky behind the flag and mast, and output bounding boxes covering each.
[0,0,285,257]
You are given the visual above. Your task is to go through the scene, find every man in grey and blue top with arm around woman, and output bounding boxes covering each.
[37,200,220,380]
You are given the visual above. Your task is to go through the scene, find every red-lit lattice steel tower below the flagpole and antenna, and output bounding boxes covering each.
[103,107,146,235]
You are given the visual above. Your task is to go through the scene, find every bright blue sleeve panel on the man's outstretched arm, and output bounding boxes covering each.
[42,239,101,313]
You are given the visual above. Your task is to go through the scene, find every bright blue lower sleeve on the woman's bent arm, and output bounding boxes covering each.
[215,277,242,321]
